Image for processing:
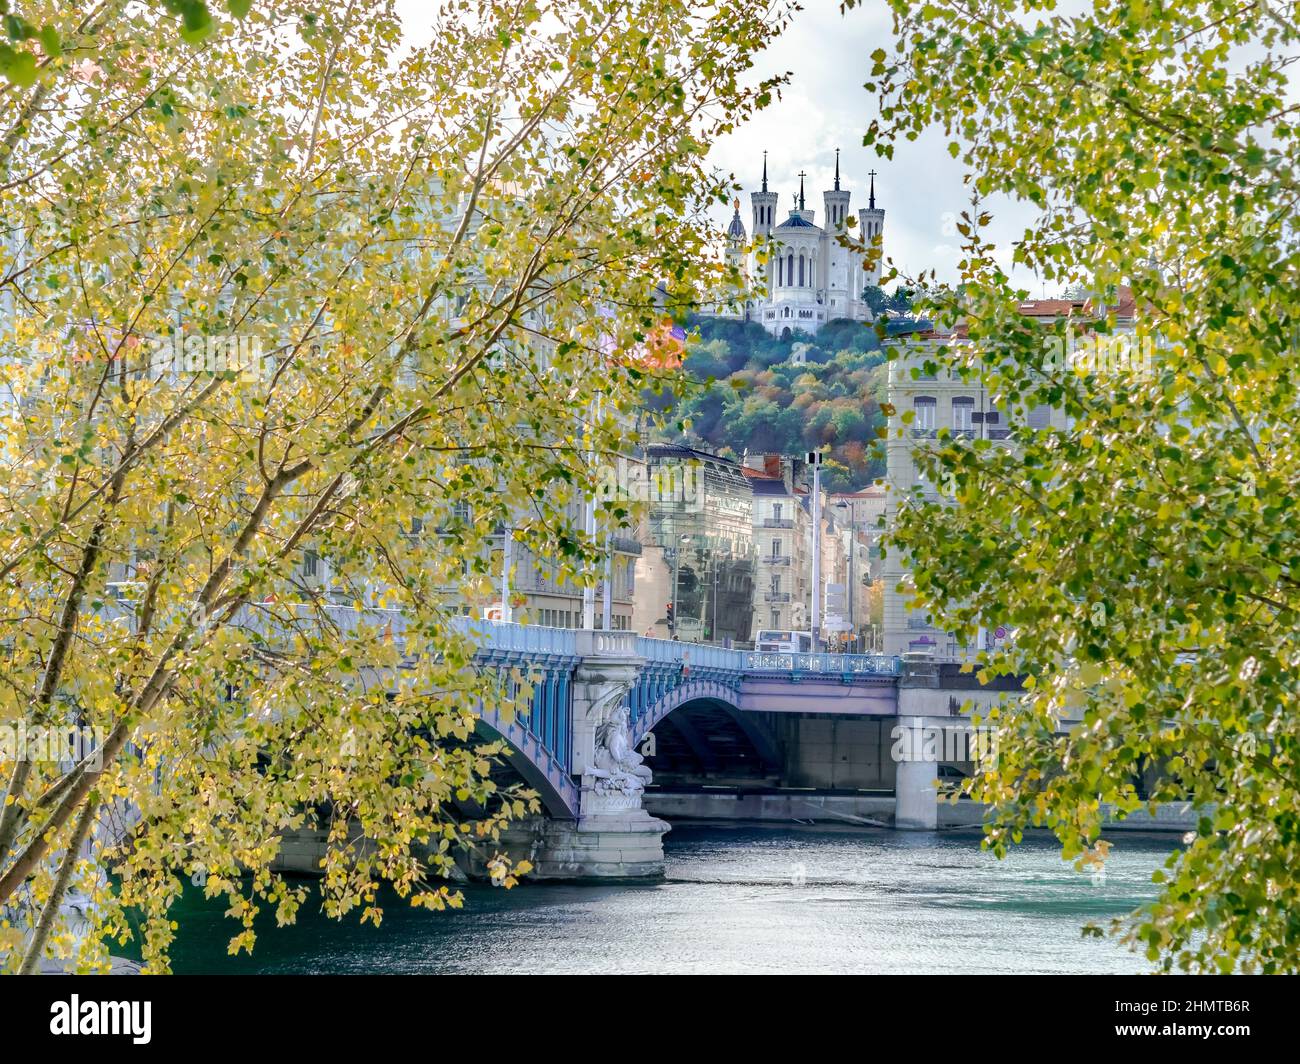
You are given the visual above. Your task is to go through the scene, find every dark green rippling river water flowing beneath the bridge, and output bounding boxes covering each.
[157,826,1177,973]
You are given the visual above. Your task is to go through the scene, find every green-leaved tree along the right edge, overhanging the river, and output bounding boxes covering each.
[849,0,1300,972]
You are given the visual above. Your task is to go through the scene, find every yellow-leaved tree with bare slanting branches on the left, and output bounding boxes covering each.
[0,0,785,970]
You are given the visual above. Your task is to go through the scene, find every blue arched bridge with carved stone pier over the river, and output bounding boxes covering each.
[226,606,998,878]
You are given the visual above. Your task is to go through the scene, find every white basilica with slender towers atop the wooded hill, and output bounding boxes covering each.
[720,150,885,336]
